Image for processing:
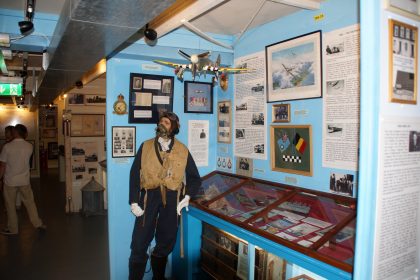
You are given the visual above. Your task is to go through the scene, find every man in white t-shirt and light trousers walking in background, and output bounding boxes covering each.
[0,124,46,235]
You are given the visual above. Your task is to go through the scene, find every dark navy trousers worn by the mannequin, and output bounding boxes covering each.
[130,188,178,263]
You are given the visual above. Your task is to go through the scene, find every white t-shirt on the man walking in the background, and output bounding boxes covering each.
[0,138,33,187]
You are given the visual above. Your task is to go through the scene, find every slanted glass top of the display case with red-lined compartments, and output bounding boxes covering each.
[193,171,356,272]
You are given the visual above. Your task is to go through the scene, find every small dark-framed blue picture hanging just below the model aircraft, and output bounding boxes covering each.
[184,81,213,114]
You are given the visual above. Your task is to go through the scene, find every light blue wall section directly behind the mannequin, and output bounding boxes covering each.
[106,30,233,279]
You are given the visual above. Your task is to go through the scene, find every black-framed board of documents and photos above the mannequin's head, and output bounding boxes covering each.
[128,73,174,123]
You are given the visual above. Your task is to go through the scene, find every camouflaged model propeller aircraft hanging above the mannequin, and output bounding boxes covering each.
[154,50,250,81]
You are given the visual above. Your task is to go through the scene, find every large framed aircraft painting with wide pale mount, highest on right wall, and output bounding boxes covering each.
[265,31,322,102]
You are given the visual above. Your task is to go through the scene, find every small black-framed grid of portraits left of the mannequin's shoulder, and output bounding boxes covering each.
[112,126,136,158]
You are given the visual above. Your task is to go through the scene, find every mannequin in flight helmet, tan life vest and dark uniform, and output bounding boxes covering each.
[129,112,201,280]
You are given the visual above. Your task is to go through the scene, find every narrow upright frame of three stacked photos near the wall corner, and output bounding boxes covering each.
[217,100,232,144]
